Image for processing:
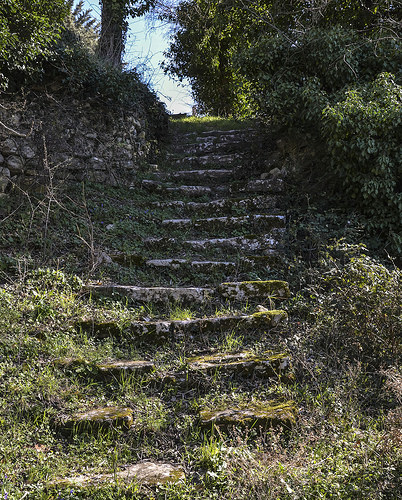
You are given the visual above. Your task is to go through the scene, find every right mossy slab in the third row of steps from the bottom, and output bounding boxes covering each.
[187,351,290,378]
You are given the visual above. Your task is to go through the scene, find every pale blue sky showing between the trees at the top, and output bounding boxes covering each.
[84,0,194,114]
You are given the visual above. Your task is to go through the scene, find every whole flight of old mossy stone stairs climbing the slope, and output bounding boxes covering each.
[50,124,297,488]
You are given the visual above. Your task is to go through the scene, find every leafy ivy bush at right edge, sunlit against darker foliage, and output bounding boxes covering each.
[322,73,402,252]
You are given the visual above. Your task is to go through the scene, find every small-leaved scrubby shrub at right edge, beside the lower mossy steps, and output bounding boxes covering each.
[310,246,402,367]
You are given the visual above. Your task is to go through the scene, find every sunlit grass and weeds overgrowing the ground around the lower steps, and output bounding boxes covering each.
[0,113,402,500]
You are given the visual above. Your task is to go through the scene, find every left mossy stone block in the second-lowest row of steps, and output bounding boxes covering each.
[58,406,133,434]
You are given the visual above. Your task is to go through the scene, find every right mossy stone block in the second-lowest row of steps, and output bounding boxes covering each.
[199,401,297,428]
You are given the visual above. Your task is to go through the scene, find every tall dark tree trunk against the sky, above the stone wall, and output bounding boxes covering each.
[98,0,155,67]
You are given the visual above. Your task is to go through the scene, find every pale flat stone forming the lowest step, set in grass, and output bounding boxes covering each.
[47,462,185,489]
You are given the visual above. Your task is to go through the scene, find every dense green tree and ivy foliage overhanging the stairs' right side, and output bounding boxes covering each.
[167,0,402,253]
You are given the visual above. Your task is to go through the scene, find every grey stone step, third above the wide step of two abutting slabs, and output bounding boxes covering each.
[162,214,286,232]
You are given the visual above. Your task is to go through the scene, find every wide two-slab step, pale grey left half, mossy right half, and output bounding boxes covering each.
[86,280,290,304]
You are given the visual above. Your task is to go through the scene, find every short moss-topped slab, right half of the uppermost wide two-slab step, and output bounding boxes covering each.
[218,280,290,301]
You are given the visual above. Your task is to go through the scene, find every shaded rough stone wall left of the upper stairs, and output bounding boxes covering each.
[0,92,164,193]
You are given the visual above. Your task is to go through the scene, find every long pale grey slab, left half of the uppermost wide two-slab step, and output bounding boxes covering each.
[87,285,212,303]
